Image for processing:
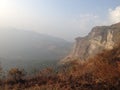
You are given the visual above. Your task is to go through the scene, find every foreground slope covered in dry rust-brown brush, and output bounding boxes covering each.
[0,43,120,90]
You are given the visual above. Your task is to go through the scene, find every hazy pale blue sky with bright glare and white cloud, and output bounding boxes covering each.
[0,0,120,41]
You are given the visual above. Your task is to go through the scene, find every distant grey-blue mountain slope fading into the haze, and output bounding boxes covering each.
[0,29,71,68]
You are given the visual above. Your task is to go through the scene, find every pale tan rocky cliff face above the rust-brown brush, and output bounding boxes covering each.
[62,23,120,62]
